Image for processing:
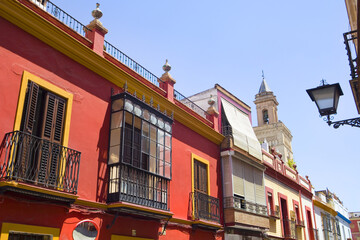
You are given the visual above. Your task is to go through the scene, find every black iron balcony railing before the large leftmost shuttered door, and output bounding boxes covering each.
[0,131,81,194]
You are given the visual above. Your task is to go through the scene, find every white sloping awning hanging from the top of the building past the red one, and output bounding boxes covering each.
[221,99,262,160]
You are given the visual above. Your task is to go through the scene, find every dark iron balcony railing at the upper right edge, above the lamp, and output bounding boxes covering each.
[344,30,358,79]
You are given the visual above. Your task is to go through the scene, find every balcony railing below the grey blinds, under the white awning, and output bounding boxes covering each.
[224,196,268,216]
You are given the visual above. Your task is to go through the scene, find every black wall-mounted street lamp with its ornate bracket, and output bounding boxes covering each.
[306,79,360,128]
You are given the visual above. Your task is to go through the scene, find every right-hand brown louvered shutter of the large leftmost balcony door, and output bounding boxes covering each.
[38,92,66,186]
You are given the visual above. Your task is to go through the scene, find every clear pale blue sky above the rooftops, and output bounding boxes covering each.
[53,0,360,211]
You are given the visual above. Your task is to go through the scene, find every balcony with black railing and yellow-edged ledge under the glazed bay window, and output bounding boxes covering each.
[108,164,171,219]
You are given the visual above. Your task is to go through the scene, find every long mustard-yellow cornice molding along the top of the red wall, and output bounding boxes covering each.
[0,0,224,144]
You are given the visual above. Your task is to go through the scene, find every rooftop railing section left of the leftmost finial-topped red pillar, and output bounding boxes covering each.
[41,0,91,37]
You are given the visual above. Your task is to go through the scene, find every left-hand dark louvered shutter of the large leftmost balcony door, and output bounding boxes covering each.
[16,82,39,179]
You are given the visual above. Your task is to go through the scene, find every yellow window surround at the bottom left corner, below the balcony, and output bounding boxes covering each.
[0,222,60,240]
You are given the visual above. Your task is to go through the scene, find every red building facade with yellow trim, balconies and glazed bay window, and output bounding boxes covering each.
[0,0,223,240]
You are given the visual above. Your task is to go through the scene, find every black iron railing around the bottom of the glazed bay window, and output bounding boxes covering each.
[108,164,170,210]
